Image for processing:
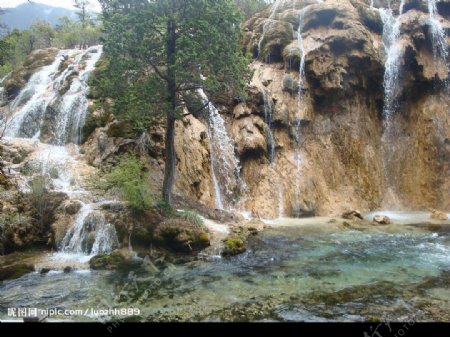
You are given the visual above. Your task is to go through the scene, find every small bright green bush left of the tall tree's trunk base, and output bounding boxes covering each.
[104,156,153,211]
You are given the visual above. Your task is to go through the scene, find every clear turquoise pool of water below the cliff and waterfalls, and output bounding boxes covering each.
[0,220,450,321]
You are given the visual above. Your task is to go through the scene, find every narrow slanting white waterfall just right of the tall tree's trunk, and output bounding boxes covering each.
[197,89,243,209]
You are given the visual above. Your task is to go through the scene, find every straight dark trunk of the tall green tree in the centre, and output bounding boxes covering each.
[163,20,177,205]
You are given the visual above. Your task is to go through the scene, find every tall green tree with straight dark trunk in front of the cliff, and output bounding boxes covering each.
[100,0,249,204]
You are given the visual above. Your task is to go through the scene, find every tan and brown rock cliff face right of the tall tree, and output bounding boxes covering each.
[171,0,450,217]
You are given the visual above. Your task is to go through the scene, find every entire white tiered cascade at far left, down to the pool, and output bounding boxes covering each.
[0,46,119,260]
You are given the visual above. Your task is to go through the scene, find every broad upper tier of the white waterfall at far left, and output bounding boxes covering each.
[6,46,102,145]
